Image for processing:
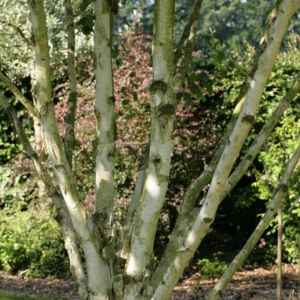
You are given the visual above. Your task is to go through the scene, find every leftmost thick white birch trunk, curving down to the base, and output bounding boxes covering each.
[28,0,111,300]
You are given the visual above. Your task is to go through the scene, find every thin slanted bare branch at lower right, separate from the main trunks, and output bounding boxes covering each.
[208,146,300,300]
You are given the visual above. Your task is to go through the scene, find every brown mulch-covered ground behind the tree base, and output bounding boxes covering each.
[0,264,300,300]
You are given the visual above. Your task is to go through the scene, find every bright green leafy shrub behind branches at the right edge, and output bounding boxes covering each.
[253,40,300,262]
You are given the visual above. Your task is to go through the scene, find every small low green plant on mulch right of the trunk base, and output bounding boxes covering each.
[197,256,227,279]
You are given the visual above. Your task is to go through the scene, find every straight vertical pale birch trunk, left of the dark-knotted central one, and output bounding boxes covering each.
[94,0,115,228]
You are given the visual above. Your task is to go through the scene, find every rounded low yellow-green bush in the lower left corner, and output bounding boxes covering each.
[0,206,70,277]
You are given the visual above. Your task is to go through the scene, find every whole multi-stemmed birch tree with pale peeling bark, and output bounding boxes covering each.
[0,0,300,300]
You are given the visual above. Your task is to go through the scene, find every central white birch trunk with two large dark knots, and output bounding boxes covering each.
[125,0,176,288]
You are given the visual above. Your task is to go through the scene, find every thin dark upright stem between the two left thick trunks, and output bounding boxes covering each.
[64,0,77,169]
